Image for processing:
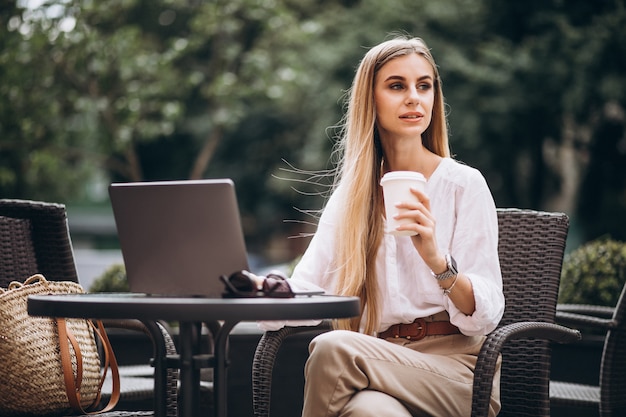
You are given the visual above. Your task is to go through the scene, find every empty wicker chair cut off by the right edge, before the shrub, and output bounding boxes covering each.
[550,286,626,417]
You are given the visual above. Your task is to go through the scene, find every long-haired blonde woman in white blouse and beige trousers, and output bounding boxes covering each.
[258,38,504,417]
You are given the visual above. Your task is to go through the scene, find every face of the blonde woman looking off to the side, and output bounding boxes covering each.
[374,53,435,142]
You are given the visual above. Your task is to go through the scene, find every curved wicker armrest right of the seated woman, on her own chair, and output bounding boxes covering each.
[472,322,581,417]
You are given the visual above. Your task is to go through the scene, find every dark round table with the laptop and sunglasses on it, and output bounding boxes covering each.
[28,293,360,417]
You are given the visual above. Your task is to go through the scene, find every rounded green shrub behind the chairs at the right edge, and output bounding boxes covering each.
[559,238,626,307]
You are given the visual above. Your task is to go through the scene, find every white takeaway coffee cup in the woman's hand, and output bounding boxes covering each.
[380,171,426,236]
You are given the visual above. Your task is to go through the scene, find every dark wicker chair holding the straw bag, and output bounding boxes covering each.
[0,199,178,417]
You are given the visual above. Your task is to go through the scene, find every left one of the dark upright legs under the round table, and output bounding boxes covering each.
[178,322,201,417]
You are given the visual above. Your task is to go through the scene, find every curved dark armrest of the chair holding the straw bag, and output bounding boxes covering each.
[102,319,178,417]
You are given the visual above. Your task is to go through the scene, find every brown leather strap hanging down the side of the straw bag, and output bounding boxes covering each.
[55,318,120,415]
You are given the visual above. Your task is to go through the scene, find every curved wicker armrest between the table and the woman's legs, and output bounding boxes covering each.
[252,321,332,417]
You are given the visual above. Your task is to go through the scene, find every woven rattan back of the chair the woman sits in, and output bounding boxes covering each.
[498,209,569,417]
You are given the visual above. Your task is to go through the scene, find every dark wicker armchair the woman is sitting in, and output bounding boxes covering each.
[252,209,580,417]
